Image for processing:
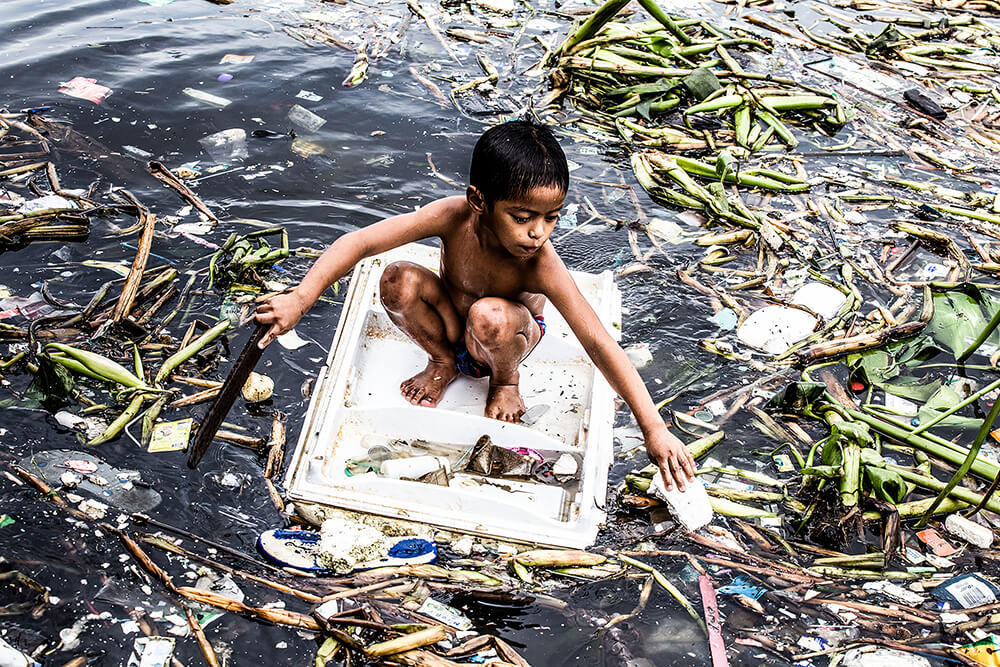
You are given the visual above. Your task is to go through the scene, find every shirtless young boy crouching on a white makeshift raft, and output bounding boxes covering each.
[257,121,694,490]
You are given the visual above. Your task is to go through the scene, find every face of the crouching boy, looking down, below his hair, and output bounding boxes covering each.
[470,185,566,259]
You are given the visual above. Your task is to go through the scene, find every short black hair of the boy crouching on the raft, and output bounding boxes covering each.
[469,120,569,207]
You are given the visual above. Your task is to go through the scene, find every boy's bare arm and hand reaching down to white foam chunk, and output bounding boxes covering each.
[537,253,694,491]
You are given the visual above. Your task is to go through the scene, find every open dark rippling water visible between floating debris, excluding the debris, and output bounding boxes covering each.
[0,0,808,667]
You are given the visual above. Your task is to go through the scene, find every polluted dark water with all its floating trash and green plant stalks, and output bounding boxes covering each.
[0,0,1000,667]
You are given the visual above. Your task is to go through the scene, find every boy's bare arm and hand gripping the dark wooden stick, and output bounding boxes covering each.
[256,197,466,348]
